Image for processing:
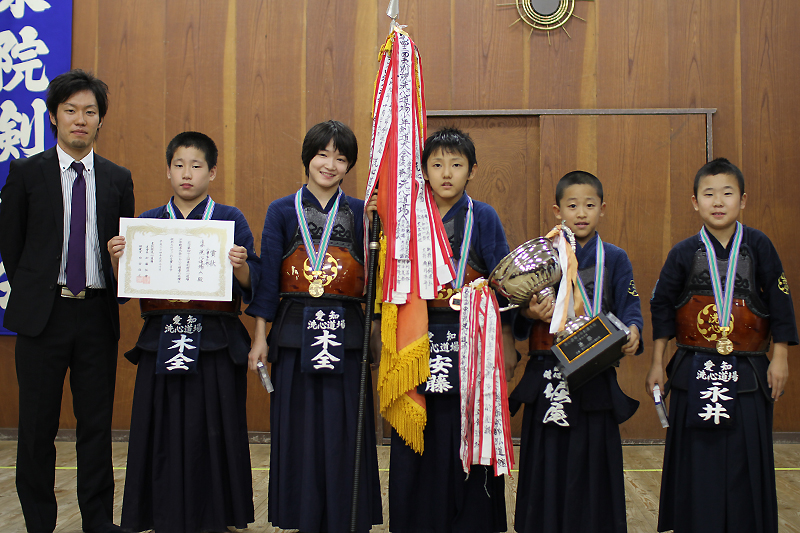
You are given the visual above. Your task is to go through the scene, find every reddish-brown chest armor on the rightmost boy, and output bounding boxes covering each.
[675,245,770,355]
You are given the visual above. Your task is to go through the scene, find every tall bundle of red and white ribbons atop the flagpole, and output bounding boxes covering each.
[364,27,455,304]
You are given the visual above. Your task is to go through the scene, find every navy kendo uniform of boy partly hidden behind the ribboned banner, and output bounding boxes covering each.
[389,193,509,533]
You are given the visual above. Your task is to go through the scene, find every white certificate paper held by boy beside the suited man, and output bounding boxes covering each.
[117,218,234,301]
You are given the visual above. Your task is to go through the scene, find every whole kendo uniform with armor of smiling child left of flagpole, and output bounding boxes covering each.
[247,186,382,533]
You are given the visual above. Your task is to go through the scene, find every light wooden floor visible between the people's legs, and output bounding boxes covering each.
[0,441,800,533]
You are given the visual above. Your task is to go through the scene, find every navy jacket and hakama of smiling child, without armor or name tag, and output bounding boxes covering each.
[247,186,383,533]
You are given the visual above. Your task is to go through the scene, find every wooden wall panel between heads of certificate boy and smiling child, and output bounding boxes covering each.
[236,1,306,431]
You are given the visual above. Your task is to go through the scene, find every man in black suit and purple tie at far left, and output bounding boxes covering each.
[0,70,134,533]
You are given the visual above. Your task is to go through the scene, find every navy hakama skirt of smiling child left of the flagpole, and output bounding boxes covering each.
[268,340,382,532]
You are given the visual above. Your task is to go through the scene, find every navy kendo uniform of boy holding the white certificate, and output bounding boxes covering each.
[122,196,259,533]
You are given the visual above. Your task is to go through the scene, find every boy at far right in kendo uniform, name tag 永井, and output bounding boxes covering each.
[646,158,798,533]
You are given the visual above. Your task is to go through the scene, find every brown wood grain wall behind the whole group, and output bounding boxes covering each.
[0,0,800,438]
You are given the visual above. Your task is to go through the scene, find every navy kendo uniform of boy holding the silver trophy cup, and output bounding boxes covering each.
[509,232,643,533]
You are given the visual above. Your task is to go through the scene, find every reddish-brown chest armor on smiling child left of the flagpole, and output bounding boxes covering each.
[280,201,364,300]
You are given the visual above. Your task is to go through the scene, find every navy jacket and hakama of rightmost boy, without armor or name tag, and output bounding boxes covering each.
[650,226,798,533]
